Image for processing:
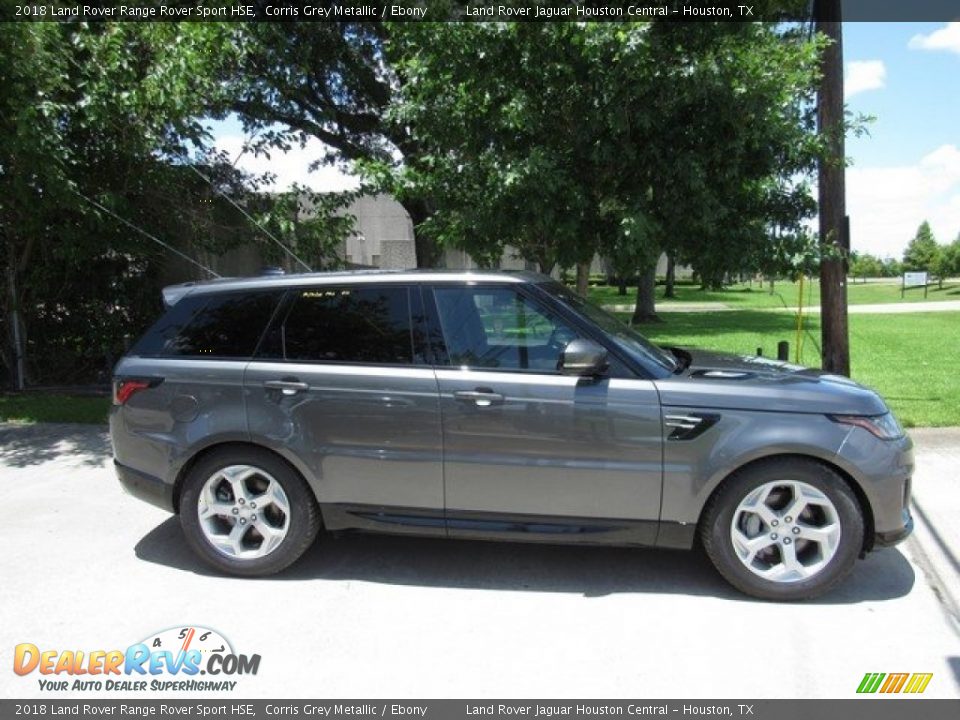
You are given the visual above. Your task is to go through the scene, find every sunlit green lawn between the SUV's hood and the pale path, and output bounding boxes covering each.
[622,310,960,427]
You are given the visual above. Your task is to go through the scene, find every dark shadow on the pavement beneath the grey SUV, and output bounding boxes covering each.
[135,517,916,605]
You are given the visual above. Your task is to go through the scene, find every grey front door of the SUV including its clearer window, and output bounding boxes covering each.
[433,284,663,544]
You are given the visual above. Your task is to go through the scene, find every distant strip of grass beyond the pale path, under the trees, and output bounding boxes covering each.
[590,279,960,309]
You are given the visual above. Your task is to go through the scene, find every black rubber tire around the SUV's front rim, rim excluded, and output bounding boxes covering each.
[702,459,864,601]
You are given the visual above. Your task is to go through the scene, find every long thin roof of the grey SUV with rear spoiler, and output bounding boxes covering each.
[163,270,551,306]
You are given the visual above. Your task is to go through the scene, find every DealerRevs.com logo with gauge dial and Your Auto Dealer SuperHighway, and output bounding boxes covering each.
[13,625,260,692]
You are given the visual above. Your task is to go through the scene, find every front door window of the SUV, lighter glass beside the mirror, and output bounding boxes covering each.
[434,286,579,373]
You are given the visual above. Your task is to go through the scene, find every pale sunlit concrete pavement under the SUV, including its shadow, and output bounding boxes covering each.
[0,425,960,699]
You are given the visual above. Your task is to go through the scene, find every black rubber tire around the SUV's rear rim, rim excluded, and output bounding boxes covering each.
[180,448,319,576]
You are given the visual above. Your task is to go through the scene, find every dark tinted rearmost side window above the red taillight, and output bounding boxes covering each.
[131,291,281,358]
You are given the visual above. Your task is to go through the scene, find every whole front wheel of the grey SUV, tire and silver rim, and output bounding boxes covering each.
[700,458,864,601]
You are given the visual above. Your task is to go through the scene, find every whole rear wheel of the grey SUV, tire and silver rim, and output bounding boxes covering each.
[180,447,320,577]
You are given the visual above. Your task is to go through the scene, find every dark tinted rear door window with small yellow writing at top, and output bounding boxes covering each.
[259,287,413,365]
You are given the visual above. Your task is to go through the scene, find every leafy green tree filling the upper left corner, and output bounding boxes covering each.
[0,23,237,384]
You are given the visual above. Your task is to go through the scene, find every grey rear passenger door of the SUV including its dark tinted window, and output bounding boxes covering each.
[244,284,443,534]
